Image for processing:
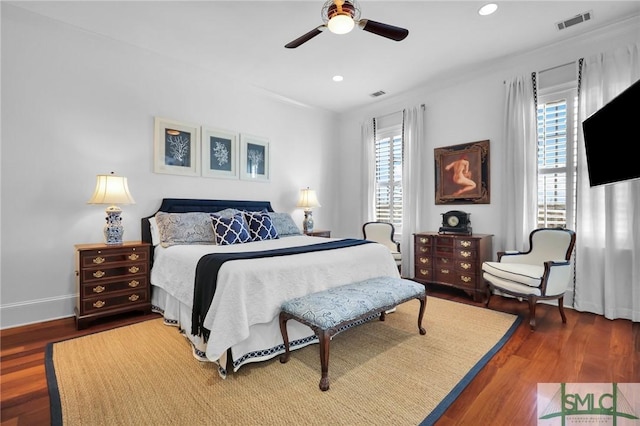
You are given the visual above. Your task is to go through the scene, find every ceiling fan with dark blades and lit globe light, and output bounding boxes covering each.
[284,0,409,49]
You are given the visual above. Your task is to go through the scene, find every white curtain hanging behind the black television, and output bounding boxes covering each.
[574,44,640,321]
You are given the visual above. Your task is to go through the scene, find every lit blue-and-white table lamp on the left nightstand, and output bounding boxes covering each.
[87,172,135,245]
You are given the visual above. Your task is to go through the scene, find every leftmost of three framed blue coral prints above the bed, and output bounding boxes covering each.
[153,117,200,176]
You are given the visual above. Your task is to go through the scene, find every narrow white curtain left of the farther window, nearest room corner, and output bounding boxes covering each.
[360,118,376,223]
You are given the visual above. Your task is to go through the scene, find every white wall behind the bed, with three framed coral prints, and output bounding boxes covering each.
[0,2,337,328]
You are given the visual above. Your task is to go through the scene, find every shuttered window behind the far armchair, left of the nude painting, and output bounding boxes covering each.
[375,120,403,234]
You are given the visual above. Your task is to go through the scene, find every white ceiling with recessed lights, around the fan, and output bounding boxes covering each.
[8,0,640,112]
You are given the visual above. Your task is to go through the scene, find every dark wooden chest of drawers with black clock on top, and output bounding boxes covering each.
[414,232,493,301]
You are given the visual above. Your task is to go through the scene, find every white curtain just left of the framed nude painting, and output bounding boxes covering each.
[400,105,428,277]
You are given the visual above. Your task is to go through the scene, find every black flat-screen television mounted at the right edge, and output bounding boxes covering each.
[582,80,640,187]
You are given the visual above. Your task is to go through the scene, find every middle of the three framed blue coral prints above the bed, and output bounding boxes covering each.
[202,126,238,179]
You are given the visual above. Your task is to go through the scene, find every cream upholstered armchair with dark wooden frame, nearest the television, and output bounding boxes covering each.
[482,228,576,331]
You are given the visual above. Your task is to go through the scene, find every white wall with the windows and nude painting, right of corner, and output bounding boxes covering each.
[337,17,640,253]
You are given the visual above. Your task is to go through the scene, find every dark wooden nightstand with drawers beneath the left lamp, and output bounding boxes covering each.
[74,241,151,330]
